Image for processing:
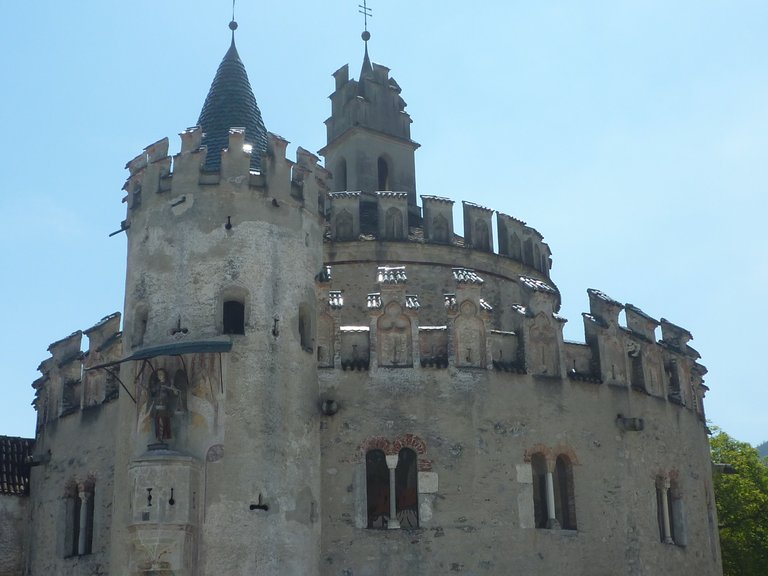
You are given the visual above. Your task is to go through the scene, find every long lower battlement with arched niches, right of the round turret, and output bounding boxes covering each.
[317,265,707,420]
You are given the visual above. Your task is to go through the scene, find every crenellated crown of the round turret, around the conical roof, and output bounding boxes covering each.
[121,126,330,220]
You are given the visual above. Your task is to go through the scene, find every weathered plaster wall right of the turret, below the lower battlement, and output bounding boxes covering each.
[320,369,719,576]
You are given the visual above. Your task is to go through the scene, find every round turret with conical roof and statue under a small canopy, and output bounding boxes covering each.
[112,23,325,575]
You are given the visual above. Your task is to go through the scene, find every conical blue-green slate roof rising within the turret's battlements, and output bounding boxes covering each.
[197,35,267,170]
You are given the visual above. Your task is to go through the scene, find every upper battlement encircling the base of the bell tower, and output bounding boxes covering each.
[327,191,552,277]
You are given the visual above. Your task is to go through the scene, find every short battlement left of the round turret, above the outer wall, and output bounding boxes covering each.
[32,312,123,433]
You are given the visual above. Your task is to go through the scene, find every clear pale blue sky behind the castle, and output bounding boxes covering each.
[0,0,768,443]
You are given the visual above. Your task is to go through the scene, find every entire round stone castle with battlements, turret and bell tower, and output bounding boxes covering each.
[0,22,722,576]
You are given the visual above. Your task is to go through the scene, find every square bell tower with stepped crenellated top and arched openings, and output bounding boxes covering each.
[320,26,419,220]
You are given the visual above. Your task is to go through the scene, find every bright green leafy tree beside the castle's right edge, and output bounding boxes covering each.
[710,431,768,576]
